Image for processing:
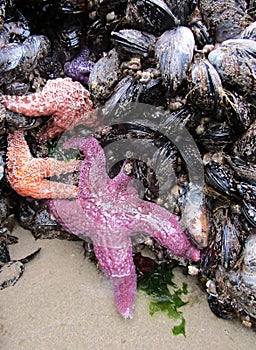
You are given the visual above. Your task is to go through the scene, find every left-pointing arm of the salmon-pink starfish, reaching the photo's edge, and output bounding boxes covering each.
[2,92,54,117]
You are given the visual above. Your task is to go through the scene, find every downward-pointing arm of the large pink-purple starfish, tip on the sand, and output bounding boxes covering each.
[94,239,137,318]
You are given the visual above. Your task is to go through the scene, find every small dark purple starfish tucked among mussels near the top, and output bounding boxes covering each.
[64,47,95,85]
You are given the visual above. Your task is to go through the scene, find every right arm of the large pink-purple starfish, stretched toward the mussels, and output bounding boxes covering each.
[132,200,200,261]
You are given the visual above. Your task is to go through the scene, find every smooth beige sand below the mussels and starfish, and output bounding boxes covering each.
[0,227,256,350]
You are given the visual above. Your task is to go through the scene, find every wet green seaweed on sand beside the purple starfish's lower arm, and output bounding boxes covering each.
[138,262,188,337]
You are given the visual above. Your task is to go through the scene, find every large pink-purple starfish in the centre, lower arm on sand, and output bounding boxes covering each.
[48,137,200,318]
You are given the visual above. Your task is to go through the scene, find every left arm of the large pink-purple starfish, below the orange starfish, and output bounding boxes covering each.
[46,199,90,238]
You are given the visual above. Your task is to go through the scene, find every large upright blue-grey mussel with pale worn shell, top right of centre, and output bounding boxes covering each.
[155,26,195,92]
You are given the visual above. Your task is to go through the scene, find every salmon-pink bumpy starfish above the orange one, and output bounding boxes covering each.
[2,78,101,141]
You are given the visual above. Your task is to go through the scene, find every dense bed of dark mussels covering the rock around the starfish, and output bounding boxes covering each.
[0,0,256,328]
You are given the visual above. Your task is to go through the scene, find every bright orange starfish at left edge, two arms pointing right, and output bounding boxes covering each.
[6,130,81,198]
